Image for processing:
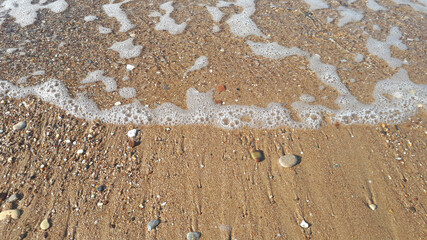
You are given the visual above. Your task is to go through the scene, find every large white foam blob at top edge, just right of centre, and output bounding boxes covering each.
[226,0,266,37]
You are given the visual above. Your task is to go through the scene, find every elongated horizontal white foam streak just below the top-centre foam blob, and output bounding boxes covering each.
[246,40,308,60]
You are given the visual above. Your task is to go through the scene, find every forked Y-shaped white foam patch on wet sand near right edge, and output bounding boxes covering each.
[366,27,407,68]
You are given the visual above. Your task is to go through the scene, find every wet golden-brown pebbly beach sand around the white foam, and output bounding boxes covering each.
[0,1,427,240]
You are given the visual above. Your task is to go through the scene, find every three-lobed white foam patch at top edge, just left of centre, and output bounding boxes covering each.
[149,1,187,34]
